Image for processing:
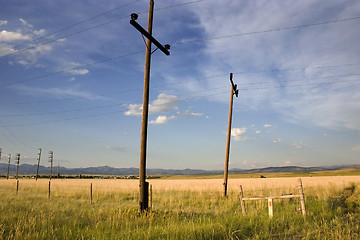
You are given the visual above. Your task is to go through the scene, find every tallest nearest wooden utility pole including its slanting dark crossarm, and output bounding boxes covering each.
[130,0,170,212]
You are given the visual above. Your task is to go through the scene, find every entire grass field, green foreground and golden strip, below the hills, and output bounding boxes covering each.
[0,174,360,239]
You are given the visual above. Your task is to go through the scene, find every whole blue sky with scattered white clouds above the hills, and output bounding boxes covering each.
[0,0,360,169]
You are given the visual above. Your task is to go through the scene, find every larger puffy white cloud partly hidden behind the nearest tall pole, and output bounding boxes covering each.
[125,93,179,116]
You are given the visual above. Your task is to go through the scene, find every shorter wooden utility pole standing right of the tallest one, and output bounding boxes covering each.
[223,73,239,197]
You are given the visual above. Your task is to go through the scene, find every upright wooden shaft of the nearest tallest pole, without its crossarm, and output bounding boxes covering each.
[139,0,154,212]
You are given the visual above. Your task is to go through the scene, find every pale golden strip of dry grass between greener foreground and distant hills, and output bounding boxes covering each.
[0,176,360,194]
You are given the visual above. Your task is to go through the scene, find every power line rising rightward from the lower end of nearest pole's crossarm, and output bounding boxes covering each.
[171,16,360,45]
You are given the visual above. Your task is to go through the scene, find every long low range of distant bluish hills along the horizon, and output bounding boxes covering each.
[0,163,360,176]
